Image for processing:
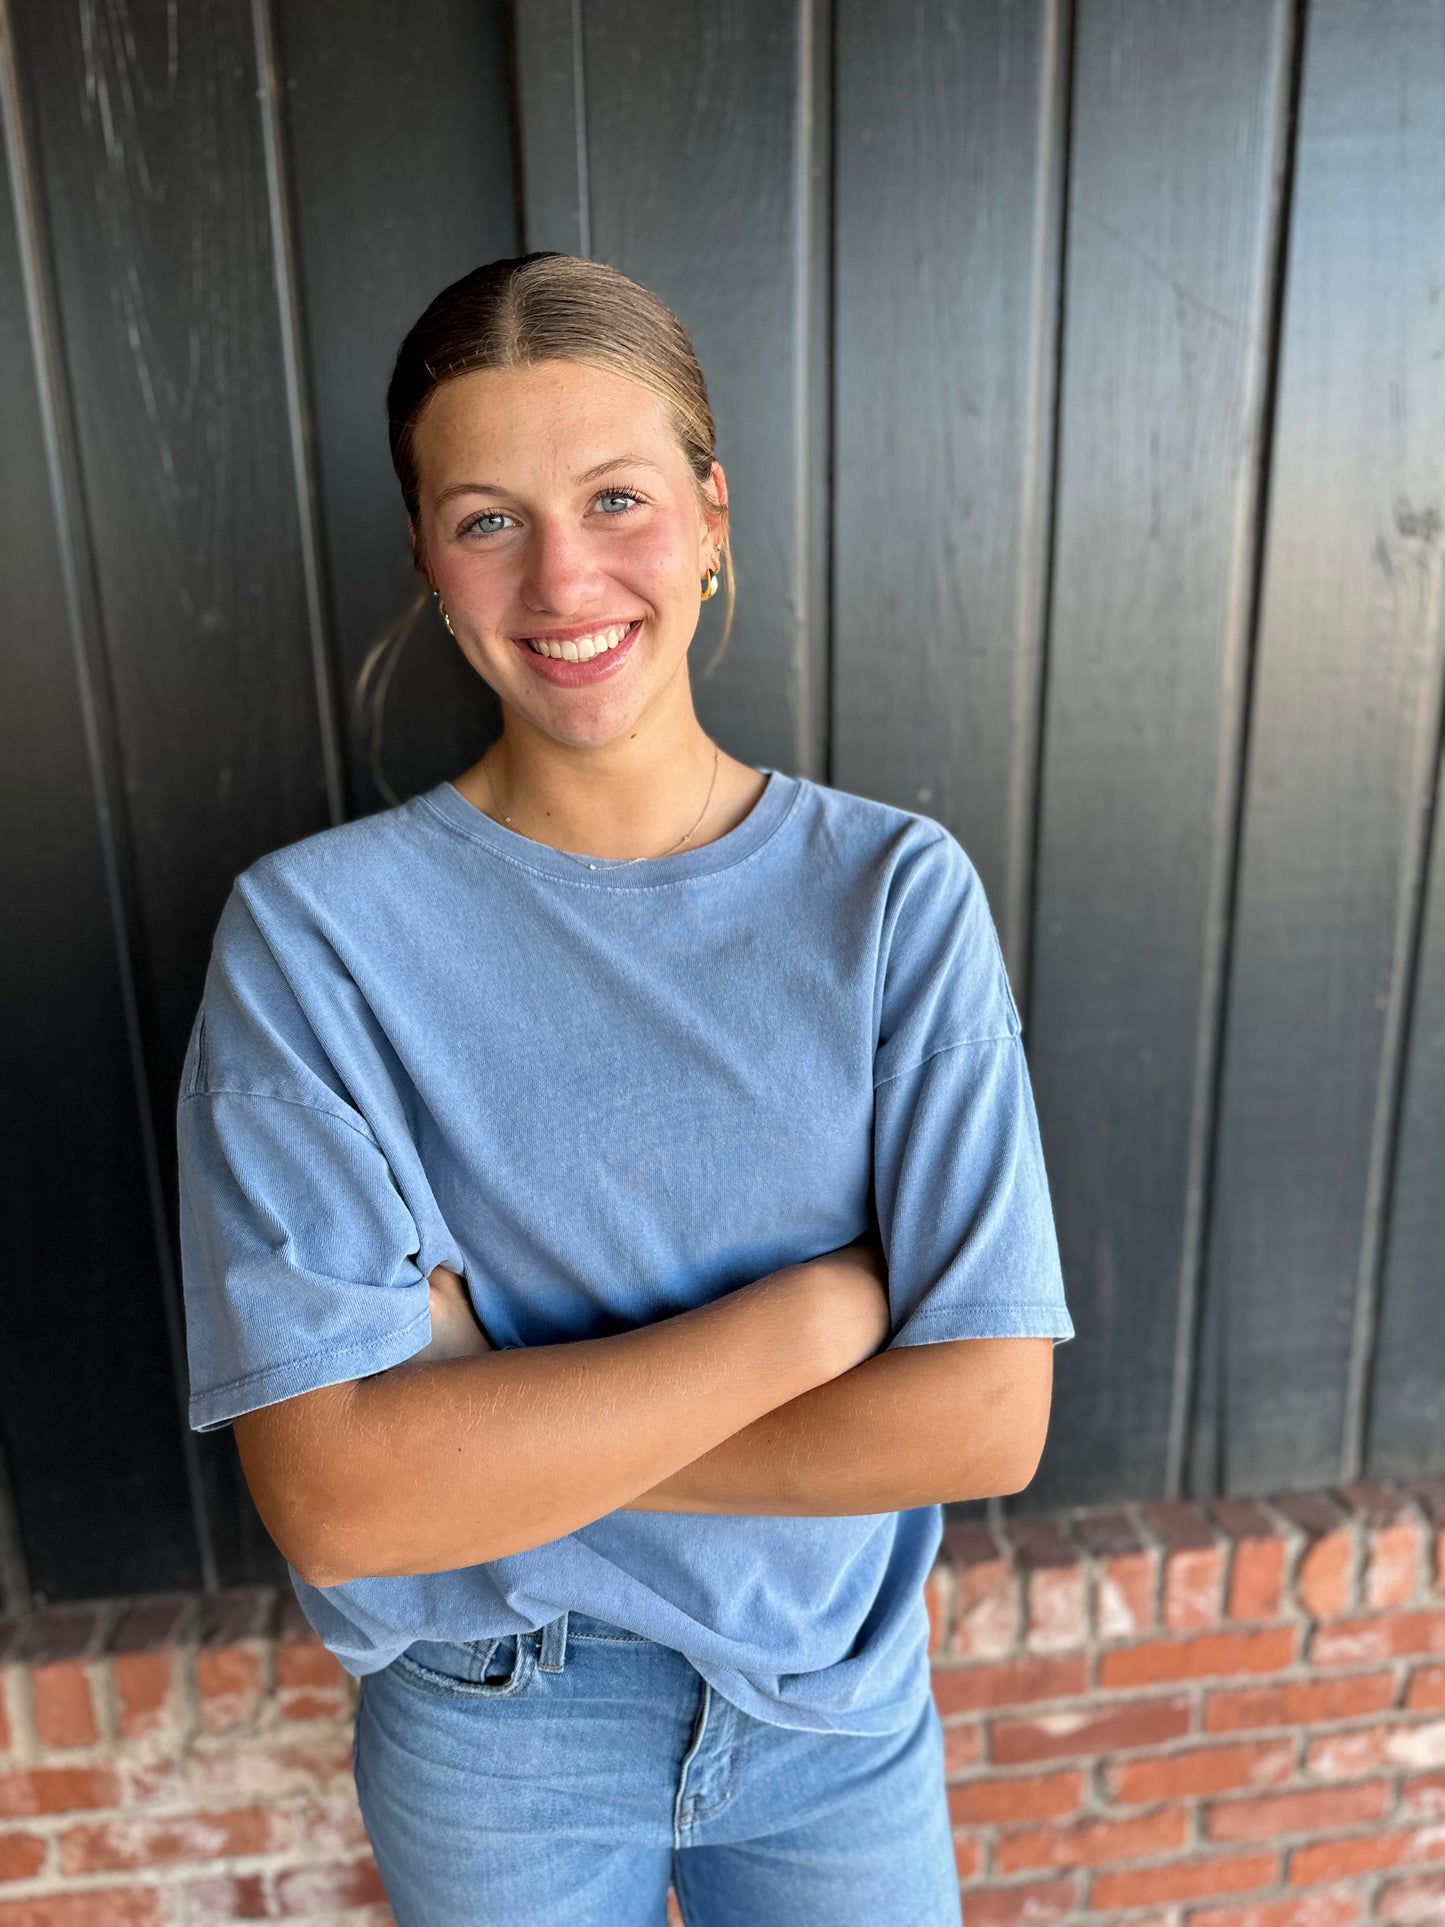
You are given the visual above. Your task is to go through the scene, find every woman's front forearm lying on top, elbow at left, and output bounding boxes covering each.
[285,1272,850,1584]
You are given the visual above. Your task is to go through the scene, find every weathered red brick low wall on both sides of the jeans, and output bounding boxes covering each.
[0,1482,1445,1927]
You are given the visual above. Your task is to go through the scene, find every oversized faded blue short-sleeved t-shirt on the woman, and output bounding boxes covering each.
[179,769,1073,1732]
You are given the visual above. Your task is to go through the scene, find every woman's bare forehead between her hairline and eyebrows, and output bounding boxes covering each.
[412,362,682,488]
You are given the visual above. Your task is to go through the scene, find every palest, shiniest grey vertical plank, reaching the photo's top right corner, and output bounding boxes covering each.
[1204,0,1445,1491]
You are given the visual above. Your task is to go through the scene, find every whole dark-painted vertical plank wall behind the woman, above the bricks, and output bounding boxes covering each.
[0,0,1445,1603]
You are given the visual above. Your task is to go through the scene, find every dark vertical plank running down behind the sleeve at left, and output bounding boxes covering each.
[17,0,342,1582]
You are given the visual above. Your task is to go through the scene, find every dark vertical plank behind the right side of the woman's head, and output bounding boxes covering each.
[566,0,832,777]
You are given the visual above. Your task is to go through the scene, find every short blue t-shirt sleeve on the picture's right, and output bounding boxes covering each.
[873,832,1073,1347]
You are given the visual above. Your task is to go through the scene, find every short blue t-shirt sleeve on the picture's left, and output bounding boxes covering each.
[177,900,432,1432]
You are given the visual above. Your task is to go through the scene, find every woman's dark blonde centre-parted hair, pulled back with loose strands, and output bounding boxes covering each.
[353,252,736,802]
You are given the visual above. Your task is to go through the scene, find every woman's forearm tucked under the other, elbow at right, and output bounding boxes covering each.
[624,1339,1054,1517]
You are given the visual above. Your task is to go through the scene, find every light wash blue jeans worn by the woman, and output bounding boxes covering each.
[353,1613,961,1927]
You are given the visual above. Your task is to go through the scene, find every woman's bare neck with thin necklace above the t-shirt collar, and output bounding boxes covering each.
[457,686,730,861]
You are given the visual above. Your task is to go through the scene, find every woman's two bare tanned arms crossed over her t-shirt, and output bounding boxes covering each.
[235,1241,1052,1586]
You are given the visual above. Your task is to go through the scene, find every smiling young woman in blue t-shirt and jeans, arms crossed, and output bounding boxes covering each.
[179,254,1073,1927]
